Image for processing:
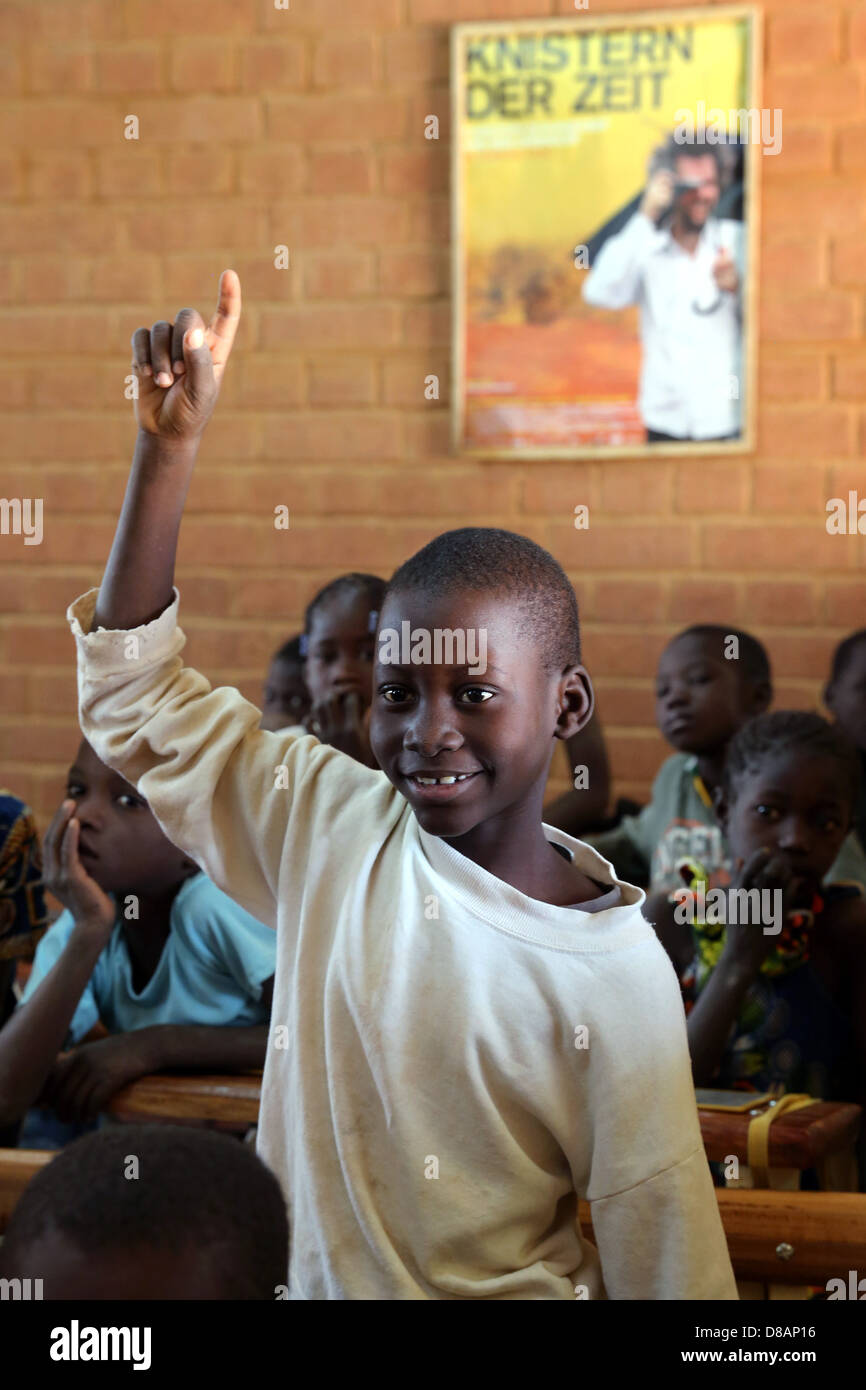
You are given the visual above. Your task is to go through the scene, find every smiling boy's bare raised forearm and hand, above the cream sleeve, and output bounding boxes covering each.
[90,270,240,631]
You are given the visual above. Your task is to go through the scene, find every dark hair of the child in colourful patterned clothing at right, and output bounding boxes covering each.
[723,709,860,806]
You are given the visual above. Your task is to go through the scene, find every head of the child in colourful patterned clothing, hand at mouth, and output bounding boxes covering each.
[717,710,860,892]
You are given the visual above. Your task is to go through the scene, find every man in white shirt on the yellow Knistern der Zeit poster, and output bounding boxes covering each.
[582,136,744,443]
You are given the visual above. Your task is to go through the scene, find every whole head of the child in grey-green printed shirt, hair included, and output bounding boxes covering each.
[656,624,773,756]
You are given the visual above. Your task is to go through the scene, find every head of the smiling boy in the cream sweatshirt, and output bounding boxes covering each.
[370,527,592,838]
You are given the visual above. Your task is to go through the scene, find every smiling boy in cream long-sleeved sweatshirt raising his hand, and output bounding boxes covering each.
[70,271,735,1300]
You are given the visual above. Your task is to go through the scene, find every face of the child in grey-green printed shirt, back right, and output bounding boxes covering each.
[656,632,767,755]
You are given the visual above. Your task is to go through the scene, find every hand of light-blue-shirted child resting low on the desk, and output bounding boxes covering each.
[38,1029,153,1123]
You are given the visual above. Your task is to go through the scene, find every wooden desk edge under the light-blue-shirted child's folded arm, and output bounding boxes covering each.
[106,1072,261,1134]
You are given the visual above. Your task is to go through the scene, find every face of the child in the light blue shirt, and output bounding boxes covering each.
[67,738,199,898]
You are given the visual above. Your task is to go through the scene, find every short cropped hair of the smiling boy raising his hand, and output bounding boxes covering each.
[388,525,581,671]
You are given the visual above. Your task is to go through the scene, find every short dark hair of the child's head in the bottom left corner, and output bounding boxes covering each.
[0,1125,289,1300]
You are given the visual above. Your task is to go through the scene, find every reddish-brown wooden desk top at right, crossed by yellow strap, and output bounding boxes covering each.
[698,1101,862,1169]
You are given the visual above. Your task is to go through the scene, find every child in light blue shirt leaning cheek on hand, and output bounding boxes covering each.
[0,742,275,1144]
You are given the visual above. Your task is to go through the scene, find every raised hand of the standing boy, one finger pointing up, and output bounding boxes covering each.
[132,270,240,441]
